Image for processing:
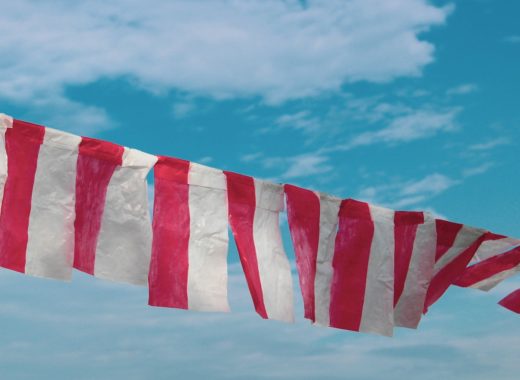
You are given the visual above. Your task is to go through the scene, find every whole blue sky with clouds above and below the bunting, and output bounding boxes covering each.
[0,0,520,380]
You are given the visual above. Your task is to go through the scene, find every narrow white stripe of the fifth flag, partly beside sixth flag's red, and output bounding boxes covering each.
[314,193,341,326]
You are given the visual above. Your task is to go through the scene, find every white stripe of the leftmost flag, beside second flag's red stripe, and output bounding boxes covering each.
[25,128,81,280]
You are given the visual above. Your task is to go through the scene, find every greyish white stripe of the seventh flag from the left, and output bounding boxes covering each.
[394,213,437,329]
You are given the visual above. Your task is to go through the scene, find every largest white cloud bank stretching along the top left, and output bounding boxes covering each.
[0,0,453,131]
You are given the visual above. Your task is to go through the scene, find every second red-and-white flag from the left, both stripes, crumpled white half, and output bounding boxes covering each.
[74,137,157,285]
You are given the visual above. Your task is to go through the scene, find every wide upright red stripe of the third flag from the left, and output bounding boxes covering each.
[148,157,190,309]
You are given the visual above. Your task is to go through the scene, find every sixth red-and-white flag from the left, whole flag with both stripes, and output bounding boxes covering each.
[329,199,394,336]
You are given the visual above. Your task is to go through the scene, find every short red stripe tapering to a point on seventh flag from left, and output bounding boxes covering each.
[394,211,424,306]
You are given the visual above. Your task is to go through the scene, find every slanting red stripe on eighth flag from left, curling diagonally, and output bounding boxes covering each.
[423,234,486,313]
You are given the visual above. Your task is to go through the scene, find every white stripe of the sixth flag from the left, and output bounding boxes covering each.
[359,205,394,336]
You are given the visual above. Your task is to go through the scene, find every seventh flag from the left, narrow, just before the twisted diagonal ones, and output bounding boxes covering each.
[394,211,437,329]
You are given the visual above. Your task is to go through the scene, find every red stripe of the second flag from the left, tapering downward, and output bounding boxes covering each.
[74,137,124,275]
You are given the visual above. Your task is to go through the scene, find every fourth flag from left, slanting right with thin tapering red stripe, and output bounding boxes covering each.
[224,172,294,322]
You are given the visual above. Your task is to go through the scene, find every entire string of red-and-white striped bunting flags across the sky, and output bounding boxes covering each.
[0,115,520,336]
